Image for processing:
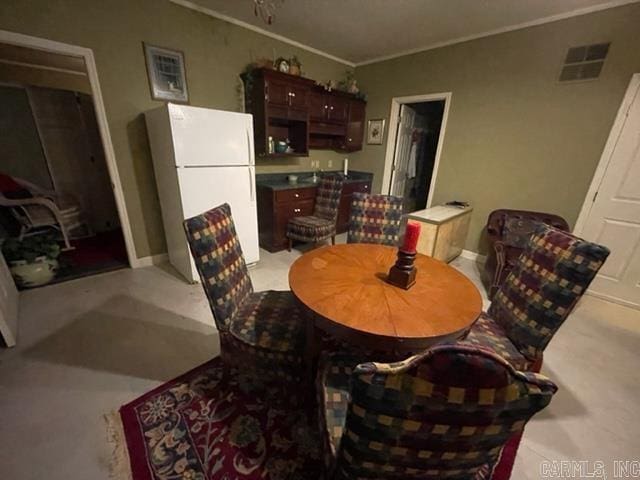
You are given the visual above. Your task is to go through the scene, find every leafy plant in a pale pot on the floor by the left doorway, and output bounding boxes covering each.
[2,234,60,287]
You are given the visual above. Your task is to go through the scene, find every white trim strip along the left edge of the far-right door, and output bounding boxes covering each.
[573,73,640,236]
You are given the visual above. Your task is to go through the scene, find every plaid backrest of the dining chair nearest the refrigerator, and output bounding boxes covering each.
[184,203,253,332]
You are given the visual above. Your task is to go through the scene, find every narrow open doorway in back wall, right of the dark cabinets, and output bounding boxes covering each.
[383,93,451,213]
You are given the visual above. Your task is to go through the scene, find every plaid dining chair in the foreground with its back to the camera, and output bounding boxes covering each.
[318,344,557,480]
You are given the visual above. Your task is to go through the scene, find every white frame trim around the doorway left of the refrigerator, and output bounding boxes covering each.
[0,30,143,268]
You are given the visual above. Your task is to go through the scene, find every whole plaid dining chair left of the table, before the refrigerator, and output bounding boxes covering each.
[184,203,304,380]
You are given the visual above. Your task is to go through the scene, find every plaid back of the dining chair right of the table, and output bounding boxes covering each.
[488,225,609,360]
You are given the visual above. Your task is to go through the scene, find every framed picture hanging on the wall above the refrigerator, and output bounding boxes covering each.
[144,43,189,103]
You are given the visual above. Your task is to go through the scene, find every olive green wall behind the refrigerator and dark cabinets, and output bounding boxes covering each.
[0,0,347,257]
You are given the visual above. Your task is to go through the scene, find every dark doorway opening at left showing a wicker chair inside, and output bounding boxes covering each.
[0,36,130,286]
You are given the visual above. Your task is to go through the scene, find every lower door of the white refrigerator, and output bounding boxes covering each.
[178,167,260,281]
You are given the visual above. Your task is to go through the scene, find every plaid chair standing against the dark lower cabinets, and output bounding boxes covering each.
[287,175,344,251]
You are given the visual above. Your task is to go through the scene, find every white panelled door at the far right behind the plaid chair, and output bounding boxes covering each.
[580,75,640,307]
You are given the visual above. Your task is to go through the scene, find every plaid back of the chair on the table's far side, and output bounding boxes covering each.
[347,193,402,246]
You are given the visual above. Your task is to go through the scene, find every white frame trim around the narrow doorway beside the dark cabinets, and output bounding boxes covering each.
[382,92,452,208]
